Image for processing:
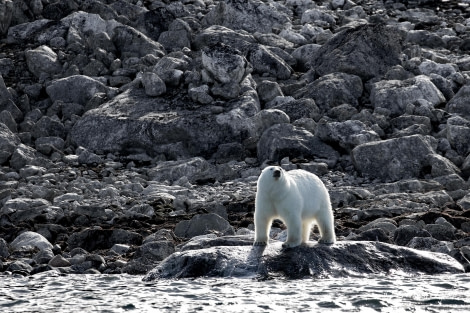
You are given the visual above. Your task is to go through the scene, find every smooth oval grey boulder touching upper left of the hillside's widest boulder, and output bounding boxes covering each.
[46,75,110,105]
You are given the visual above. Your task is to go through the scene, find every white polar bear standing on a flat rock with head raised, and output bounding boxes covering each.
[254,166,336,248]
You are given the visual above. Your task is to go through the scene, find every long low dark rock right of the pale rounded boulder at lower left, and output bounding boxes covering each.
[67,228,142,251]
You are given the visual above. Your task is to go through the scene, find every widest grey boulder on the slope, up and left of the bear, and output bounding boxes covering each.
[71,89,257,159]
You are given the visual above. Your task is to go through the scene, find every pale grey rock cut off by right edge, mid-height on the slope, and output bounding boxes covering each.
[447,116,470,156]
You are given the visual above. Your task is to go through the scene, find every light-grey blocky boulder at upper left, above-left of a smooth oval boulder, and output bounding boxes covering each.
[25,46,62,78]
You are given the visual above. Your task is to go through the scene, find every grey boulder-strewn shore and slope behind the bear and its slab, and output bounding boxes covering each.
[0,0,470,275]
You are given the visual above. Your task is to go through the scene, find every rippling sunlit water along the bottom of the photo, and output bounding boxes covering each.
[0,273,470,313]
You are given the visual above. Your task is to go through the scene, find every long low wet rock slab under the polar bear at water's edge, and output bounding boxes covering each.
[144,236,464,281]
